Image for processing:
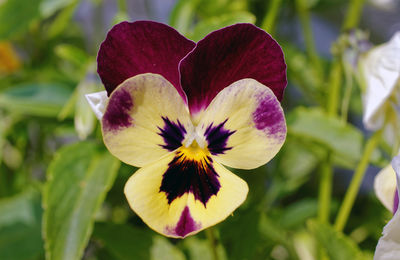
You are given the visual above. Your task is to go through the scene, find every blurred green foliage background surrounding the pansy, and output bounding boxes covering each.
[0,0,392,260]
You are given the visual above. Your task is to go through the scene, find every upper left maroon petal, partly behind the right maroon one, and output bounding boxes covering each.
[97,21,195,97]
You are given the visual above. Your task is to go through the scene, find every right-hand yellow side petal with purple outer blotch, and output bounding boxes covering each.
[196,79,286,169]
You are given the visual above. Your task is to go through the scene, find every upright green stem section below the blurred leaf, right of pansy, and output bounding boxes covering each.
[318,152,333,223]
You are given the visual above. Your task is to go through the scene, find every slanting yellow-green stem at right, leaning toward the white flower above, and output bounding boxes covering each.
[335,130,382,231]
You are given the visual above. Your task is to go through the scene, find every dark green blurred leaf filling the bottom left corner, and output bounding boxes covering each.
[0,189,44,260]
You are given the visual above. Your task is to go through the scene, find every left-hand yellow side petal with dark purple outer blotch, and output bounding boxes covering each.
[102,73,193,167]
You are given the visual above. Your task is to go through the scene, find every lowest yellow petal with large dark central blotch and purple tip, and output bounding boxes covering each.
[125,152,248,238]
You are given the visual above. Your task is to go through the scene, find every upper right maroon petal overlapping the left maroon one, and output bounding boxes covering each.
[179,24,287,114]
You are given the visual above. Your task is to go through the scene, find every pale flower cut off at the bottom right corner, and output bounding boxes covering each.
[374,155,400,260]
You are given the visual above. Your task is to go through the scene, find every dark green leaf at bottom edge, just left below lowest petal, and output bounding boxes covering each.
[93,223,153,260]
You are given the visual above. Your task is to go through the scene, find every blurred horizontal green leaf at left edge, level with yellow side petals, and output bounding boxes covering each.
[0,83,72,117]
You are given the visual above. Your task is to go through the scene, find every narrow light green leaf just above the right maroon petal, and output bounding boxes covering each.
[188,11,256,41]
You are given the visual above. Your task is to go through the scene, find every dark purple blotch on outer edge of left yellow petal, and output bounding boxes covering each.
[102,88,133,131]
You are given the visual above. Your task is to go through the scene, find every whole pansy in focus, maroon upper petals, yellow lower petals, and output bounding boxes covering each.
[87,21,287,238]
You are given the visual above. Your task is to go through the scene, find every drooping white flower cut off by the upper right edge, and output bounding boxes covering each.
[360,32,400,143]
